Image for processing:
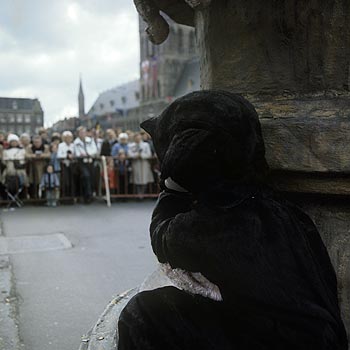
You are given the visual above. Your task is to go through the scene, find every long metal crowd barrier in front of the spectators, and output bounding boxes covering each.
[0,157,159,205]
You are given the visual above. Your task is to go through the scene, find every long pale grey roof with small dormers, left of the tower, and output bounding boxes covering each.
[88,80,140,117]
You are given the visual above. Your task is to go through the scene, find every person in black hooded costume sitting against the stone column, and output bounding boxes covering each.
[118,91,347,350]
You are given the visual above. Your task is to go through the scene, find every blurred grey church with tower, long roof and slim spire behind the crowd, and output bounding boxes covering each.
[78,18,200,130]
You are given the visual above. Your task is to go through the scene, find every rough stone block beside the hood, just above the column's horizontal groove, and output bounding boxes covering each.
[261,112,350,174]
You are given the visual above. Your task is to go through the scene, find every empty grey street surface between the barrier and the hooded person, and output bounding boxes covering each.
[0,201,156,350]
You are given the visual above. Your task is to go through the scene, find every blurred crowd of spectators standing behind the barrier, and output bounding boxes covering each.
[0,127,158,206]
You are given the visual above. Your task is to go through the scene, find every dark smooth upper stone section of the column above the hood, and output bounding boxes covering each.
[195,0,350,95]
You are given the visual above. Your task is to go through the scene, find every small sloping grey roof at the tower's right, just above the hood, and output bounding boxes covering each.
[174,58,200,98]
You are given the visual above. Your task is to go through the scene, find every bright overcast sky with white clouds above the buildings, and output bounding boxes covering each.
[0,0,139,125]
